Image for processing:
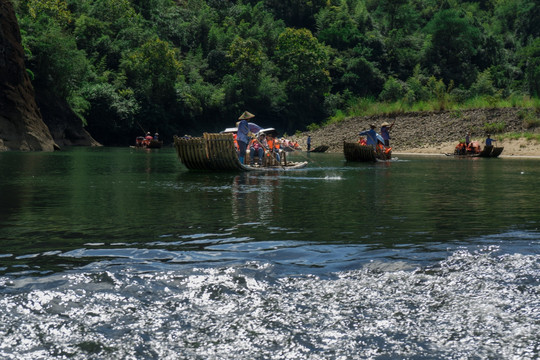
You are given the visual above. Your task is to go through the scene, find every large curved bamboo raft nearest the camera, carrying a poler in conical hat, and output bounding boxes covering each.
[174,133,307,171]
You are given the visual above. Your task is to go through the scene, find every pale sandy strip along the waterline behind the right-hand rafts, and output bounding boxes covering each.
[393,139,540,158]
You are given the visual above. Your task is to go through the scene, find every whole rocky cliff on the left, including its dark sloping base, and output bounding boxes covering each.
[0,0,99,151]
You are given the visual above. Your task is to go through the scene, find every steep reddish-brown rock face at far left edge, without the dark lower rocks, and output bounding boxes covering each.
[0,0,55,151]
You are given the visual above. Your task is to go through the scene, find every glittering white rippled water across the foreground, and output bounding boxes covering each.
[0,248,540,359]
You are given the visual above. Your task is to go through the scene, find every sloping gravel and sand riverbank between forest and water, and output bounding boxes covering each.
[295,108,540,157]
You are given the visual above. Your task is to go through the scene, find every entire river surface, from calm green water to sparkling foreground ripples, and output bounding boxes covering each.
[0,148,540,359]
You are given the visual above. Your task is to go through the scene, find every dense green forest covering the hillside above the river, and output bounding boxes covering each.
[12,0,540,145]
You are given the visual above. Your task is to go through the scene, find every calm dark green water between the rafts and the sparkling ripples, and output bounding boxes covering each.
[0,148,540,272]
